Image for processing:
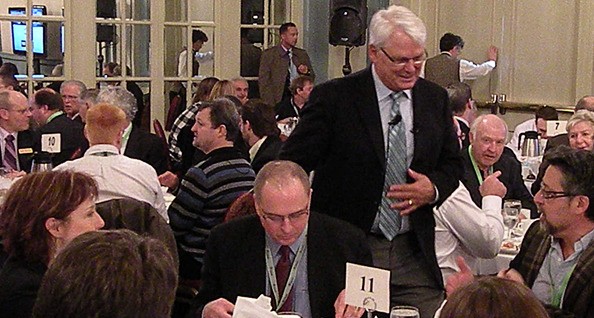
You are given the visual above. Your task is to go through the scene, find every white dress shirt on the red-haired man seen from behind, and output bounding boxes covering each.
[54,145,169,223]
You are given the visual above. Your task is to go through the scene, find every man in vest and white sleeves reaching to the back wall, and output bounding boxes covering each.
[425,33,497,87]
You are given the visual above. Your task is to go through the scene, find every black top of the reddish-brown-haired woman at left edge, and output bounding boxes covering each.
[0,256,47,318]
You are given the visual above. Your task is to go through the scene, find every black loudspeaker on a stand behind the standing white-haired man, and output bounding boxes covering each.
[329,0,367,46]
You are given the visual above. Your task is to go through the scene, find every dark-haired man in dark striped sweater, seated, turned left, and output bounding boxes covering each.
[168,98,255,280]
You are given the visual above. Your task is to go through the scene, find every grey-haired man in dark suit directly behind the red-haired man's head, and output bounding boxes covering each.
[97,86,169,175]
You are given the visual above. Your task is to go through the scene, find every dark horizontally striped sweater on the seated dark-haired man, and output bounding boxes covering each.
[168,147,255,263]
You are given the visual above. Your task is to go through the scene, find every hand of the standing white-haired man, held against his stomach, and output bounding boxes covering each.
[387,169,435,215]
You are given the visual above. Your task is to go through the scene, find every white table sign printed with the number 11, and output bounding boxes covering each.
[345,263,390,313]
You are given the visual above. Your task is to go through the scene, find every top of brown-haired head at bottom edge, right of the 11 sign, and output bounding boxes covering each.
[440,276,549,318]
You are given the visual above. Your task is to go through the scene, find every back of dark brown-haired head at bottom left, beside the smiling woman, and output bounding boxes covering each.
[33,230,177,318]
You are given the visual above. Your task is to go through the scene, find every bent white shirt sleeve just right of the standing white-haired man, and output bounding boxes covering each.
[435,183,504,258]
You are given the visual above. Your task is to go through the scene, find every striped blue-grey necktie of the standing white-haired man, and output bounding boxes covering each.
[379,92,407,241]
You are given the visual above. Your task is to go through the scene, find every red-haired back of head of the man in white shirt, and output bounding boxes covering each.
[85,103,127,145]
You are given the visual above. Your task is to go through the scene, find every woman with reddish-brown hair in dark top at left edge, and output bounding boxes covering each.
[0,171,104,317]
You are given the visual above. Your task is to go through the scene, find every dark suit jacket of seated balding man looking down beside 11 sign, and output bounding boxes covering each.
[195,212,371,317]
